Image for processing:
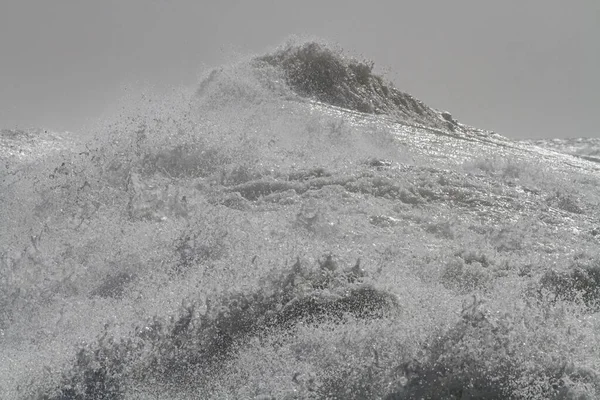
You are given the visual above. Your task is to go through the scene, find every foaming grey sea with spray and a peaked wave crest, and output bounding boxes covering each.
[0,43,600,400]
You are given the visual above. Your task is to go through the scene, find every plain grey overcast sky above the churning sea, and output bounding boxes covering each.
[0,0,600,137]
